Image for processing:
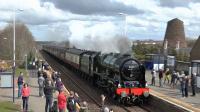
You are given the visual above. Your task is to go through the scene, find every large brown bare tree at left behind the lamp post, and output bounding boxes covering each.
[0,23,35,65]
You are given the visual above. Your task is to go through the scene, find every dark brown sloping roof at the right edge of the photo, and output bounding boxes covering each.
[190,36,200,60]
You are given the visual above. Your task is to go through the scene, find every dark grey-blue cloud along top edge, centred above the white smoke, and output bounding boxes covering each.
[45,0,142,15]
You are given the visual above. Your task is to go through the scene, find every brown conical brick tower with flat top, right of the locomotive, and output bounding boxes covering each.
[163,18,187,49]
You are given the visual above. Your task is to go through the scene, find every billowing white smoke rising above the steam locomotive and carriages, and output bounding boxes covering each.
[69,21,131,53]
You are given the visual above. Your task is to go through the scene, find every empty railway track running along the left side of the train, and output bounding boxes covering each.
[41,52,147,112]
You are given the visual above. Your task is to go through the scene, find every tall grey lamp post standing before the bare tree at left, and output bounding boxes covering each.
[13,8,23,103]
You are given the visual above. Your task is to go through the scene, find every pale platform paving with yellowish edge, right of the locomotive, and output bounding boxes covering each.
[146,71,200,109]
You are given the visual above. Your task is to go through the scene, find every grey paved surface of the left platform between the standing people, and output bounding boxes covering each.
[0,70,56,112]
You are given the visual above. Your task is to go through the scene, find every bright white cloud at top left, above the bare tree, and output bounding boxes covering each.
[0,0,68,25]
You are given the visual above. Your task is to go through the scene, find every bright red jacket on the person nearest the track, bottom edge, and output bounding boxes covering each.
[58,92,67,109]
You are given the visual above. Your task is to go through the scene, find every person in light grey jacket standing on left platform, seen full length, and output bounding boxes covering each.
[38,73,45,97]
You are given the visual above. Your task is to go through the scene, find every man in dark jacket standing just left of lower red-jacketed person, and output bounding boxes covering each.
[44,79,55,112]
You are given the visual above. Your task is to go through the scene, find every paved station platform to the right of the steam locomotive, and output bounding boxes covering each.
[146,71,200,112]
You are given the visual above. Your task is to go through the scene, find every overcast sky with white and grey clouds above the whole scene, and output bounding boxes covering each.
[0,0,200,41]
